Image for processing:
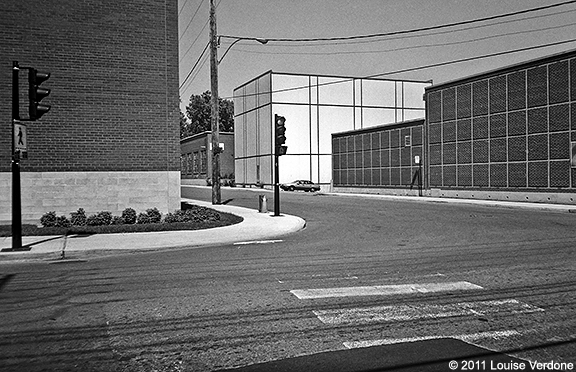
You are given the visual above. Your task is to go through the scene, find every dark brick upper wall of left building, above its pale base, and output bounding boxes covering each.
[0,0,179,172]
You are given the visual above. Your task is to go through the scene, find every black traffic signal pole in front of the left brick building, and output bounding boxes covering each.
[12,61,22,250]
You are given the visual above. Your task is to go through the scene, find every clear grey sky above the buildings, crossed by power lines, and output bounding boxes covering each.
[178,0,576,111]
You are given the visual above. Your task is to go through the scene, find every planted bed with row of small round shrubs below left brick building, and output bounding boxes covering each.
[0,203,243,237]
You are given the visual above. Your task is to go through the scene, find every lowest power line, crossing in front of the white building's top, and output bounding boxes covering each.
[223,39,576,99]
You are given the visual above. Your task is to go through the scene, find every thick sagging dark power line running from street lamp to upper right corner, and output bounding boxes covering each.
[220,0,576,42]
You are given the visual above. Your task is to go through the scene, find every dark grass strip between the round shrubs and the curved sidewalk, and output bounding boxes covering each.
[0,203,243,237]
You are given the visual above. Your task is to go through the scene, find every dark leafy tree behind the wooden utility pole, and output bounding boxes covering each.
[180,91,234,138]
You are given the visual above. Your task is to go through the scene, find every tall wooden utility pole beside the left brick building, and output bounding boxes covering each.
[210,0,222,204]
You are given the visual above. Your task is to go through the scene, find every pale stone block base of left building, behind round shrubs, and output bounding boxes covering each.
[0,171,180,224]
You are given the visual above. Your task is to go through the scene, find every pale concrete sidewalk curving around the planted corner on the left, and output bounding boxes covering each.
[0,199,306,263]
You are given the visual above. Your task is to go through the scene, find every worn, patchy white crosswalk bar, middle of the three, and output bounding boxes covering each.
[313,299,544,324]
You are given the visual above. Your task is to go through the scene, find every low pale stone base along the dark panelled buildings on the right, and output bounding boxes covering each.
[332,187,576,205]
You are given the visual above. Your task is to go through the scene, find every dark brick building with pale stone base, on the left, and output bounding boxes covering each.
[0,0,180,221]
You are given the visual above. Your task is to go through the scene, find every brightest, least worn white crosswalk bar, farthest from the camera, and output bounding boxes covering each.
[290,282,483,300]
